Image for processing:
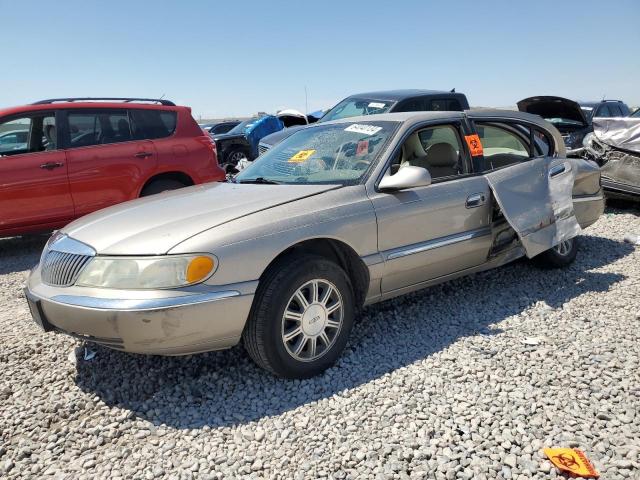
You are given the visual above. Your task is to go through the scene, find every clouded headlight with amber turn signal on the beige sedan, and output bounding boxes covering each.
[76,255,217,289]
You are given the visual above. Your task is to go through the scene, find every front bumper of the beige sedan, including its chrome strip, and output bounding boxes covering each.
[25,272,257,355]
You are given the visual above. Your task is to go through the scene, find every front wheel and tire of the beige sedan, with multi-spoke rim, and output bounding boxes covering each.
[242,254,355,379]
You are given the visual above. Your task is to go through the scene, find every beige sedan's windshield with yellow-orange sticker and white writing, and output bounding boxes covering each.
[235,121,398,185]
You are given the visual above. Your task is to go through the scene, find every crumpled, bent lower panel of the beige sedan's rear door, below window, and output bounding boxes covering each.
[485,158,580,258]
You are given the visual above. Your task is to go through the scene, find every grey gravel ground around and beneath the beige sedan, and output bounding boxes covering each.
[0,210,640,480]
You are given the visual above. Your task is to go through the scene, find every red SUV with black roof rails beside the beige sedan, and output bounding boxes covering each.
[0,98,225,237]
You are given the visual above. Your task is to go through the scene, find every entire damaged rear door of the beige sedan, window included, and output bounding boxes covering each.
[474,120,580,258]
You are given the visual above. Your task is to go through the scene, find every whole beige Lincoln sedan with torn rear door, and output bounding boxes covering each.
[25,110,604,378]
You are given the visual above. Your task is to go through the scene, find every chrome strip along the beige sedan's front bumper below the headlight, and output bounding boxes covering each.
[44,290,240,312]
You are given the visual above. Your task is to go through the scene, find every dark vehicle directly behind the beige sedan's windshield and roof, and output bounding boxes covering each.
[258,89,469,154]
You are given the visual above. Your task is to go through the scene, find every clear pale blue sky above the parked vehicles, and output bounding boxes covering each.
[0,0,640,118]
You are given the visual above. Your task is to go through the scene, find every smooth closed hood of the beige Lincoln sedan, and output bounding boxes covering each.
[62,183,338,255]
